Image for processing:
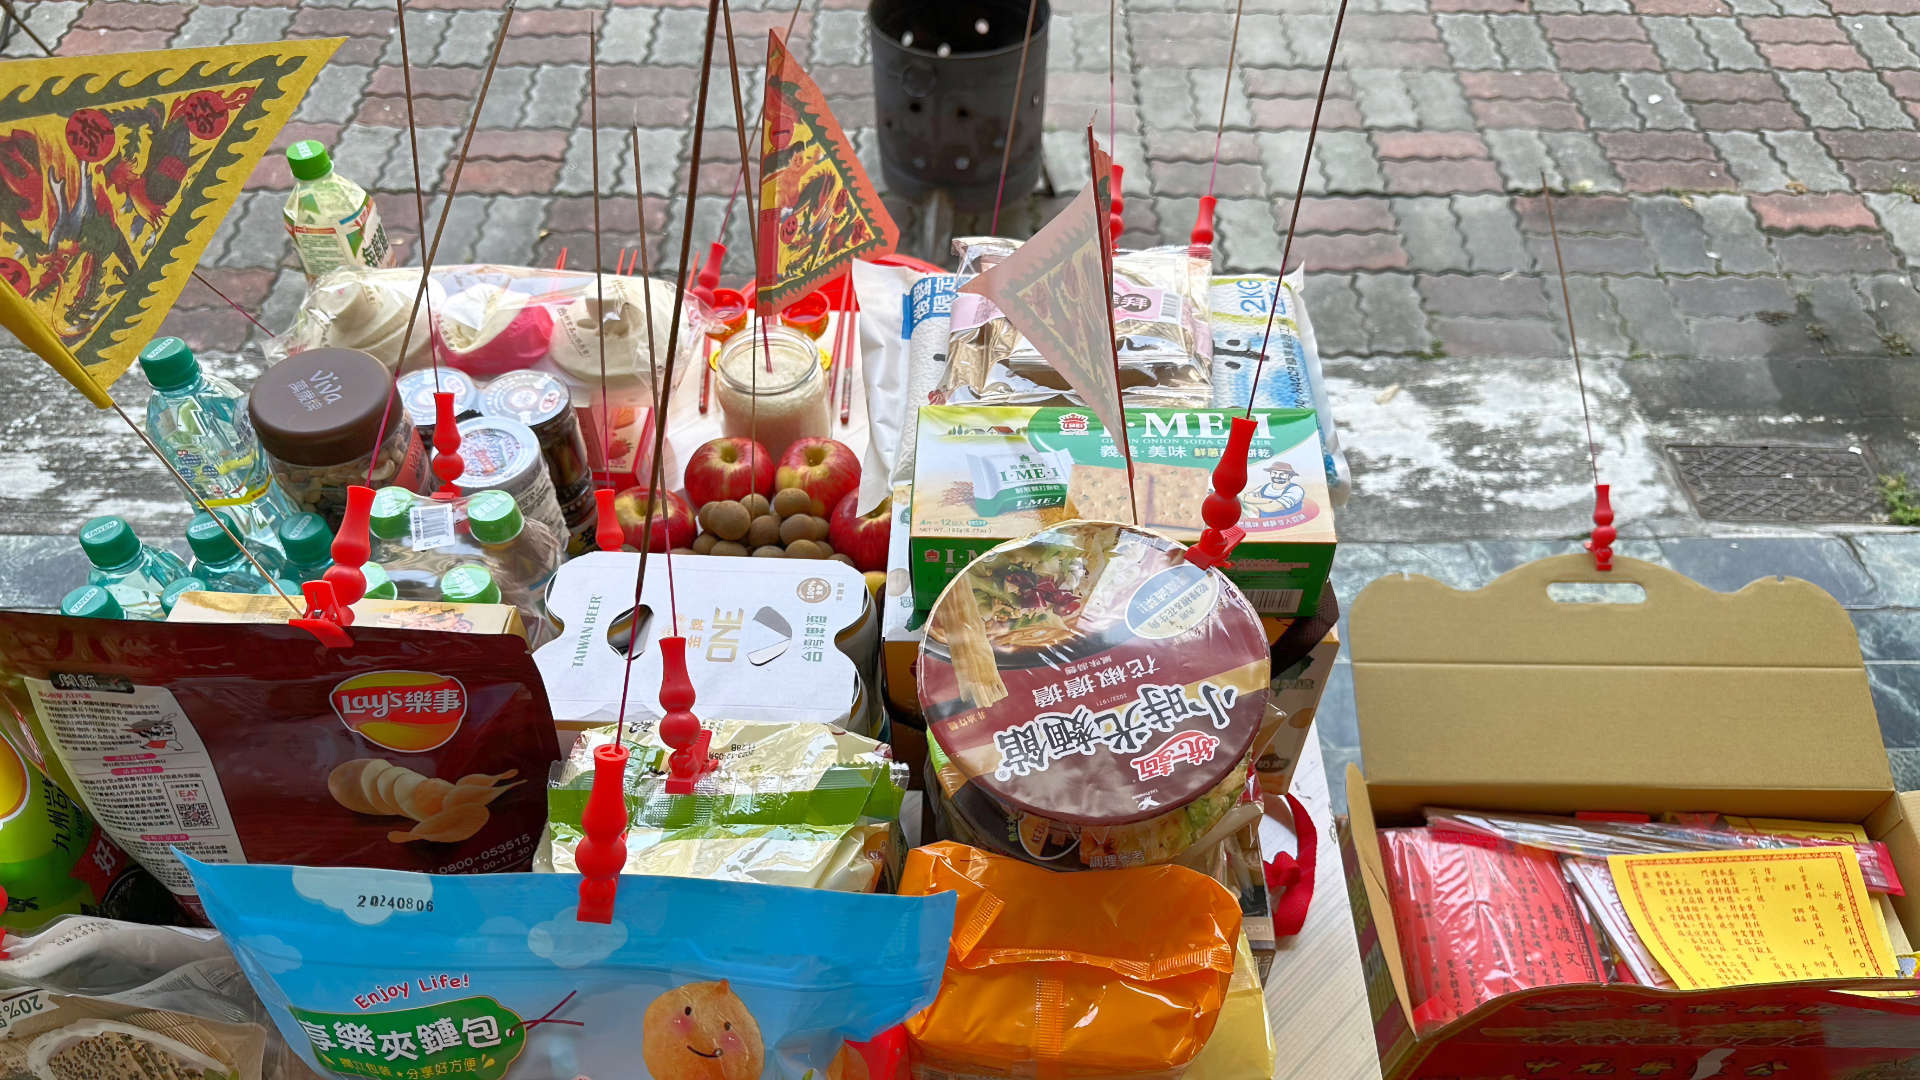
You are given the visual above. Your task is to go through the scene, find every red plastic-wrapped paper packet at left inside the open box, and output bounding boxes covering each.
[1380,828,1607,1032]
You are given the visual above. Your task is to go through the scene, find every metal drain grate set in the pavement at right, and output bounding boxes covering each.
[1667,444,1885,523]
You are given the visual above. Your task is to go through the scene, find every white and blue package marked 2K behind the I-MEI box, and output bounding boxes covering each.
[1208,267,1352,505]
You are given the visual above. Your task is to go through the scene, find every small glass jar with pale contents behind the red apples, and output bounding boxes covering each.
[714,325,831,461]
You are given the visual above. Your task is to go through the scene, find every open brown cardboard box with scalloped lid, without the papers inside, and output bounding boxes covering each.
[1342,555,1920,1080]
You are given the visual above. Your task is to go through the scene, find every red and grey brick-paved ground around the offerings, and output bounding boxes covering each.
[0,0,1920,788]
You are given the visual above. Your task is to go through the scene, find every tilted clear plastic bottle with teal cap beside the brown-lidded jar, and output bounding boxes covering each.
[140,338,294,569]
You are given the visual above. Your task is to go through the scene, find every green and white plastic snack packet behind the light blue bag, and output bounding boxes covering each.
[534,721,906,892]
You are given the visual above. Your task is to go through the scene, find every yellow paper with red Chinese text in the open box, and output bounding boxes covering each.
[1607,847,1899,990]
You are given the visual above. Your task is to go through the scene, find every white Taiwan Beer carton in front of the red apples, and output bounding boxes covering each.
[534,552,881,746]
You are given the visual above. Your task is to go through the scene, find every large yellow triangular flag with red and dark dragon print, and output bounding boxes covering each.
[0,38,344,407]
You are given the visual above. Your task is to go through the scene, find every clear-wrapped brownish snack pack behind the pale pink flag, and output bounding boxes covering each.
[935,236,1213,405]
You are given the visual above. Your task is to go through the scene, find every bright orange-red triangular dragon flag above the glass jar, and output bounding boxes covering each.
[756,31,900,315]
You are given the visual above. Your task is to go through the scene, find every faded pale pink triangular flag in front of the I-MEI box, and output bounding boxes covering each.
[960,135,1127,450]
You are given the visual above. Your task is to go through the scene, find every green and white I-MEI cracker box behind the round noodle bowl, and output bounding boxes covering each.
[908,405,1336,617]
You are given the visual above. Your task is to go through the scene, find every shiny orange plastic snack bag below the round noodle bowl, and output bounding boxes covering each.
[900,842,1240,1080]
